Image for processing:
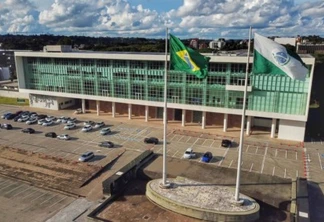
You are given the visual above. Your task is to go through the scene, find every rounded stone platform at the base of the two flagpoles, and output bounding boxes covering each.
[146,177,260,221]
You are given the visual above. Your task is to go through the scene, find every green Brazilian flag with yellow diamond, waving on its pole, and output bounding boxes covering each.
[170,34,210,79]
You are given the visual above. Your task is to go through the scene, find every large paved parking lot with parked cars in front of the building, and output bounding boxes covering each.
[0,104,306,178]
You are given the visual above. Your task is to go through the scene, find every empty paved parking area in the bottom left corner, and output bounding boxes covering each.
[0,177,75,222]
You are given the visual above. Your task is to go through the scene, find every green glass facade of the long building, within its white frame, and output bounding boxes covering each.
[23,57,309,115]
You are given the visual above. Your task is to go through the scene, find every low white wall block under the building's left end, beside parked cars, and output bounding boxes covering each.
[29,94,59,110]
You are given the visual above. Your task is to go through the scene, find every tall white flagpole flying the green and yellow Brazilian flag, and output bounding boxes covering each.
[161,28,169,188]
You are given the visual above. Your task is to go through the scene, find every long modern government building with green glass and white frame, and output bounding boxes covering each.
[15,46,315,141]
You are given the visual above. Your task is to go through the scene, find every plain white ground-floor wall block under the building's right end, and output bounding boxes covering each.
[278,119,306,141]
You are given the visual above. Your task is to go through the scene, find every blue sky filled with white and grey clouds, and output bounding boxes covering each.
[0,0,324,39]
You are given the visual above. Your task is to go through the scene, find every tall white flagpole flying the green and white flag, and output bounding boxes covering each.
[235,26,252,203]
